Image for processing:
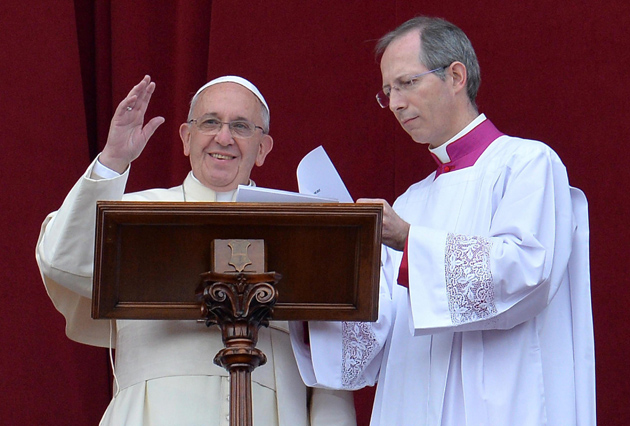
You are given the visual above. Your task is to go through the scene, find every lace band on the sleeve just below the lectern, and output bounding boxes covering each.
[341,322,378,389]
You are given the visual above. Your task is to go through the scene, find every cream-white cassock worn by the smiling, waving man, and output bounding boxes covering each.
[36,160,356,426]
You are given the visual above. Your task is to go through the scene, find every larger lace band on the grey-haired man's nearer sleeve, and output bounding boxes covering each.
[444,234,497,324]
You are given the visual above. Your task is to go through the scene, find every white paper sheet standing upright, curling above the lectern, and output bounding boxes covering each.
[297,145,354,203]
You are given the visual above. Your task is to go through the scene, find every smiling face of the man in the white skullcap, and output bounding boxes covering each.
[179,82,273,192]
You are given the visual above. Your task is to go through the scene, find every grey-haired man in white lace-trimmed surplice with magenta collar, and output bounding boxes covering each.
[291,17,595,426]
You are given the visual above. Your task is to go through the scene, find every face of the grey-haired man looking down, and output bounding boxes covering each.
[381,31,470,147]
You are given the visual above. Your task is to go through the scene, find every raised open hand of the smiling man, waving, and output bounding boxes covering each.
[99,75,164,173]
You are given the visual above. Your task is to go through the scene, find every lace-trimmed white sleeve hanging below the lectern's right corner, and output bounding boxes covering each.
[290,246,394,390]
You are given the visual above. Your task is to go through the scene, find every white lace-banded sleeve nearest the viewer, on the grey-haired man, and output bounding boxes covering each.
[408,146,574,335]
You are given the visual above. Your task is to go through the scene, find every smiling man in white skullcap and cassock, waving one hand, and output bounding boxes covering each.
[36,76,356,426]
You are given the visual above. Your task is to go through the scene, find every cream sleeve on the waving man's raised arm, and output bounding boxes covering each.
[35,160,129,347]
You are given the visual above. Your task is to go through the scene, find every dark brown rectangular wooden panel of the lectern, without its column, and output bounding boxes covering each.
[92,201,382,321]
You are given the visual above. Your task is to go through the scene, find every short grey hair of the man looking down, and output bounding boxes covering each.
[375,16,481,108]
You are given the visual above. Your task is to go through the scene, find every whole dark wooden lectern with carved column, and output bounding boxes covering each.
[92,201,382,426]
